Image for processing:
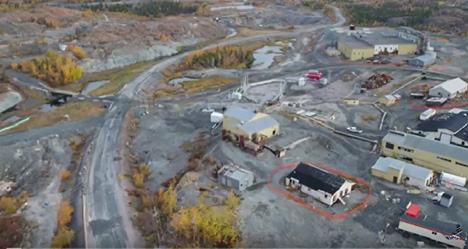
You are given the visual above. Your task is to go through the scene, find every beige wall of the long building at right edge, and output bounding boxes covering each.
[382,140,468,177]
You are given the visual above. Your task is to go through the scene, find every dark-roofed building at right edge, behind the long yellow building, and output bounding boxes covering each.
[412,110,468,146]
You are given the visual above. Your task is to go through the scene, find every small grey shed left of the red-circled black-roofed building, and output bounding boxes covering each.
[218,165,255,191]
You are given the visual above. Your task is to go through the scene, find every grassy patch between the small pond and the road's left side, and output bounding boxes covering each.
[88,61,155,97]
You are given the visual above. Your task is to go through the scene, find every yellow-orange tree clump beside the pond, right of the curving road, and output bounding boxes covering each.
[179,45,254,70]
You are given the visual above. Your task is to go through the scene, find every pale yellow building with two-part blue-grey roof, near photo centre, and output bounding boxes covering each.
[223,107,279,142]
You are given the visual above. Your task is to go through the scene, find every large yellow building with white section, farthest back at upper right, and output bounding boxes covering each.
[338,33,417,61]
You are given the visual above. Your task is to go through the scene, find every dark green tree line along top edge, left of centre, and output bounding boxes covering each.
[82,1,197,17]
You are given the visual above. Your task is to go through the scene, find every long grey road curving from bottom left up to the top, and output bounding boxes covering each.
[84,5,345,248]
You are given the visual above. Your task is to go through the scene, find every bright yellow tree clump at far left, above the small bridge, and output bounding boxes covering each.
[10,50,84,87]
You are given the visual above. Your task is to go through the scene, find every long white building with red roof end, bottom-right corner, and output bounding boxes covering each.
[398,203,467,249]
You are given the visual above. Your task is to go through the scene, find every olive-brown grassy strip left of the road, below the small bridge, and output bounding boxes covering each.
[1,102,106,135]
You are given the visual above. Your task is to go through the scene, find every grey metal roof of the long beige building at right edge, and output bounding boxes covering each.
[382,132,468,163]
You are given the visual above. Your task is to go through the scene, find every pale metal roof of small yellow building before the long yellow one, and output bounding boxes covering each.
[372,157,432,181]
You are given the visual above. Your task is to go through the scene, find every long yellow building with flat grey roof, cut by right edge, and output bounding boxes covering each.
[382,131,468,177]
